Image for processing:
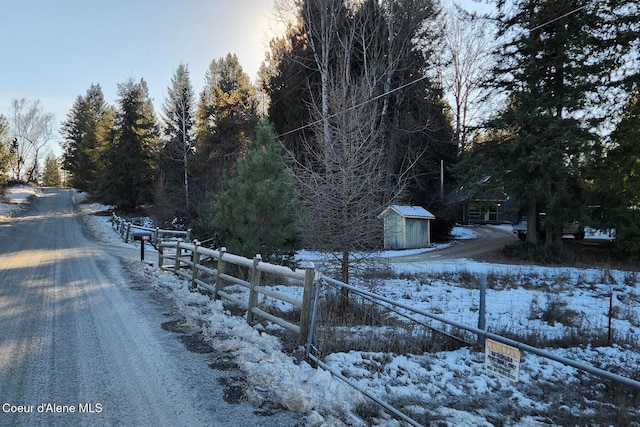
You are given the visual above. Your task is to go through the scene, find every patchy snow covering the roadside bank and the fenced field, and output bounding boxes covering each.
[0,188,640,427]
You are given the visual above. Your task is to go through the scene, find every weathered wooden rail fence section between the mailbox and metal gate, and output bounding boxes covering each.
[157,240,316,345]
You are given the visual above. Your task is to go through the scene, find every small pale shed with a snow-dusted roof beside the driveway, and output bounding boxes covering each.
[378,205,436,249]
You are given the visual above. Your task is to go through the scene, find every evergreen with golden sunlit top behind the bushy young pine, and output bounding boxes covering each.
[191,54,258,200]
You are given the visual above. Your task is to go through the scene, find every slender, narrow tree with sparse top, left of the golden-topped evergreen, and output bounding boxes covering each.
[156,64,194,215]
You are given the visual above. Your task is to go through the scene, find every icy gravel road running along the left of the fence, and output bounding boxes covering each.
[0,189,296,426]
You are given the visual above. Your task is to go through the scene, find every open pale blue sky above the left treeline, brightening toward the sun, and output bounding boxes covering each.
[0,0,275,151]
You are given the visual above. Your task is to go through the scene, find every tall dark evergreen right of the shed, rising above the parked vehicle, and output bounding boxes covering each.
[460,0,616,243]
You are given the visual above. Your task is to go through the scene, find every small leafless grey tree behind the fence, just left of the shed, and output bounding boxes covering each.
[296,68,403,282]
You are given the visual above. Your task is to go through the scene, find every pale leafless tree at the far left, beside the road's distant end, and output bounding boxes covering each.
[10,98,54,181]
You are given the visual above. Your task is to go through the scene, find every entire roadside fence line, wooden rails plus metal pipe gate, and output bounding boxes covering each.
[107,222,640,426]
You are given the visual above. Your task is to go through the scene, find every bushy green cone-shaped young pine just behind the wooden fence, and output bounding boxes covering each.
[199,124,299,261]
